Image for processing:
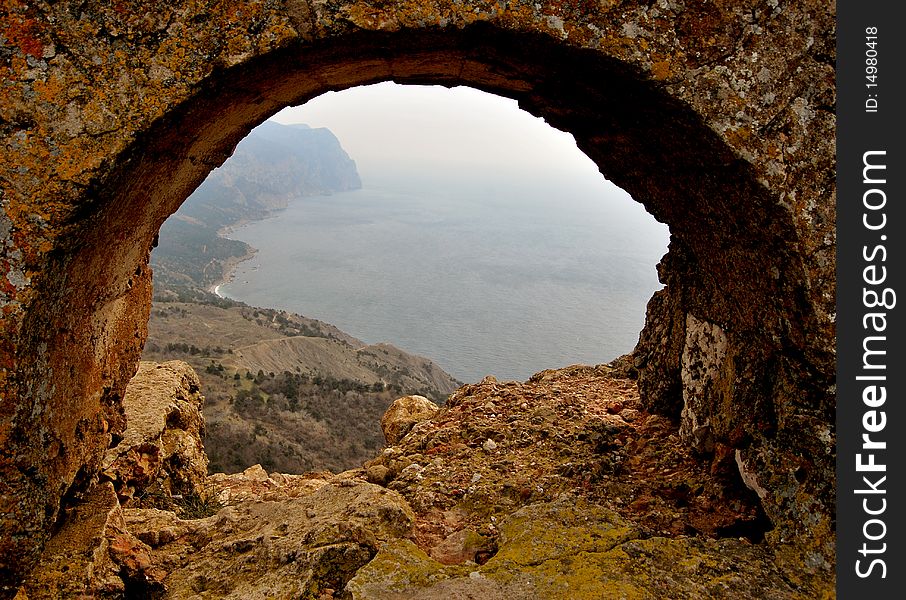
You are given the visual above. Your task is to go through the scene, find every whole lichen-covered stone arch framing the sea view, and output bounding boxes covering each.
[0,0,834,590]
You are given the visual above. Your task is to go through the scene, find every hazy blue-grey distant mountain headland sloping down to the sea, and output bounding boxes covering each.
[151,121,362,300]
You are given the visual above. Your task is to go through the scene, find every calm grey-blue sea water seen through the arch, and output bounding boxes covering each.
[219,174,668,381]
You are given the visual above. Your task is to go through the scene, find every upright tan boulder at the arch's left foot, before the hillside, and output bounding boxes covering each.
[102,361,208,508]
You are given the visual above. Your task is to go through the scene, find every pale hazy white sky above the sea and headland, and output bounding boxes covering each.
[273,82,597,180]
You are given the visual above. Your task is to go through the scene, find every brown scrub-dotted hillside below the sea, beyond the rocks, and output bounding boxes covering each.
[144,301,459,473]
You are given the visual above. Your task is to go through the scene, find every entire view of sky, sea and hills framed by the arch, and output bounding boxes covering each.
[143,84,668,473]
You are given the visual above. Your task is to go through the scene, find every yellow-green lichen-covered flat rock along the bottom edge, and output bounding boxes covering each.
[346,495,804,600]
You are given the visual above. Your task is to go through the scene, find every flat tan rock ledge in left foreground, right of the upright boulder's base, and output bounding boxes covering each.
[125,477,414,600]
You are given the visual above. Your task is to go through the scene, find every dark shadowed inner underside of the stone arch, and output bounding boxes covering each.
[4,16,833,592]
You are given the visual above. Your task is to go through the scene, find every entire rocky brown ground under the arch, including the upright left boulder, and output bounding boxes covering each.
[18,362,833,600]
